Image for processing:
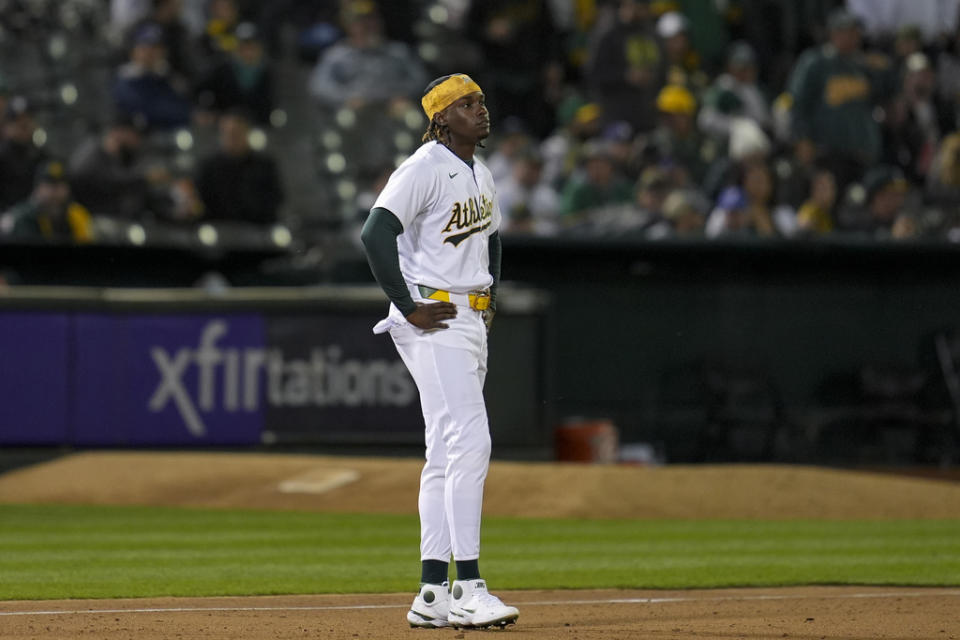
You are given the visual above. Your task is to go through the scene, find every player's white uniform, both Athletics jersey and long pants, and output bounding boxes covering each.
[373,142,500,562]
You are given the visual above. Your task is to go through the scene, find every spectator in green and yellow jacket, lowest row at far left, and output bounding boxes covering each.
[0,160,94,243]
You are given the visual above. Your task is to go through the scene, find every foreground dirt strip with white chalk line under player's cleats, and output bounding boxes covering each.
[0,587,960,640]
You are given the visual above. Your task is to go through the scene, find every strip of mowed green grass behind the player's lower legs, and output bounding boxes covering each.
[0,505,960,599]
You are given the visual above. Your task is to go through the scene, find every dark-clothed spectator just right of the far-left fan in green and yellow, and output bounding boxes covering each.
[69,114,168,220]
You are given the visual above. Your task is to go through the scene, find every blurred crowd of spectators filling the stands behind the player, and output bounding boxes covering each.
[0,0,960,245]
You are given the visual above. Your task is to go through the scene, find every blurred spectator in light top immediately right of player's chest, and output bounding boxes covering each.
[497,147,560,236]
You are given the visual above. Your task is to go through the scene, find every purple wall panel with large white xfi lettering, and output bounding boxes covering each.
[74,314,265,445]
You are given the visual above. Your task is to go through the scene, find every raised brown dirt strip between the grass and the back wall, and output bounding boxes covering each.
[0,452,960,519]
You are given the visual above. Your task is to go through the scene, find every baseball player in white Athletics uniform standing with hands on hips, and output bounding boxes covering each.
[361,74,519,628]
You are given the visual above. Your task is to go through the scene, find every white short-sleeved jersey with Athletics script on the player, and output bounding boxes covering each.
[373,142,500,293]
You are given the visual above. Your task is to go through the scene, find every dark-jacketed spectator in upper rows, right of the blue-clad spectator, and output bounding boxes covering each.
[194,22,274,125]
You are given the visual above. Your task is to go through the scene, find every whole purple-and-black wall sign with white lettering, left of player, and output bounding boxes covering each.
[61,314,422,445]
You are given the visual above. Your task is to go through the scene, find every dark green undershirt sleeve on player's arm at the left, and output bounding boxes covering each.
[360,207,417,316]
